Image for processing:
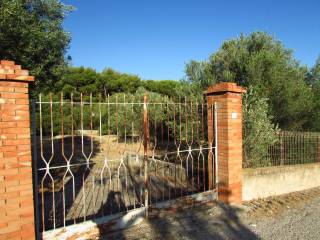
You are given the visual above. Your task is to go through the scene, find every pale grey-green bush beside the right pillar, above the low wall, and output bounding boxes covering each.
[243,86,278,167]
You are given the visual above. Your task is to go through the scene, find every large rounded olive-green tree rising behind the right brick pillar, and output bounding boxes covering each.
[186,32,312,130]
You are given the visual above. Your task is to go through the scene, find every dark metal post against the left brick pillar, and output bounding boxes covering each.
[31,99,41,239]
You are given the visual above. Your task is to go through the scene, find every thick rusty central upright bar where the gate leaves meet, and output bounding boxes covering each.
[143,95,149,218]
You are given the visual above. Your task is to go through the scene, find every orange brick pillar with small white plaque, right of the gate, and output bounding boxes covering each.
[205,82,245,203]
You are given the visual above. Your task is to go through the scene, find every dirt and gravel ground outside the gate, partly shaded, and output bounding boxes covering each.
[95,188,320,240]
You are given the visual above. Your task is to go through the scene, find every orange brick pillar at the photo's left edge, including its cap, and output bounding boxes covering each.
[0,61,35,239]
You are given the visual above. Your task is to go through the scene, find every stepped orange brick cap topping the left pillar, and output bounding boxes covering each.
[0,60,34,82]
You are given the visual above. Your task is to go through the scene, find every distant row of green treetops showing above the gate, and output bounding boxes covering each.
[51,67,185,99]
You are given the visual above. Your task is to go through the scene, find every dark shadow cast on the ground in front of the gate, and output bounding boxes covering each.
[100,202,260,240]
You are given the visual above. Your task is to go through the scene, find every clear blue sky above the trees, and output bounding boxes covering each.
[63,0,320,80]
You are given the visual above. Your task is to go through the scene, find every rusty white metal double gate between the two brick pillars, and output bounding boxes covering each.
[32,94,217,235]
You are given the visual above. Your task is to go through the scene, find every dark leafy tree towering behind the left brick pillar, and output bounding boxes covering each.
[0,0,72,92]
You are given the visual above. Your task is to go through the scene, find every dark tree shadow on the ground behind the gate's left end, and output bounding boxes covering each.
[36,136,99,230]
